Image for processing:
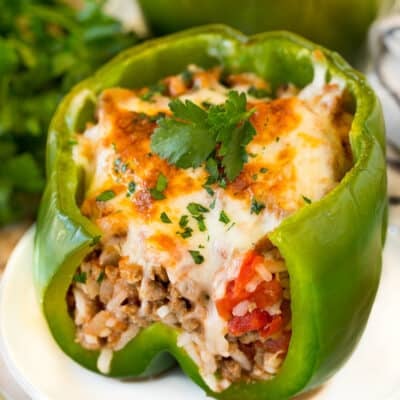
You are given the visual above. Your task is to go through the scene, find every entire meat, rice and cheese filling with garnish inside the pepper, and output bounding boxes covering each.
[67,59,352,391]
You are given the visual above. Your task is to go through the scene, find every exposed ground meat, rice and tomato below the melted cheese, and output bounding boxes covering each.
[67,242,291,382]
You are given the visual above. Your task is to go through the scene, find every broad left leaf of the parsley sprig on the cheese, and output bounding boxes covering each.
[151,99,215,168]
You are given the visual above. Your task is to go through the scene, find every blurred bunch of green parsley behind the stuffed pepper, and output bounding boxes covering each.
[0,0,137,226]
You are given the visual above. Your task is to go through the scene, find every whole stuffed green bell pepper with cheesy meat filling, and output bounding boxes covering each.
[35,26,386,399]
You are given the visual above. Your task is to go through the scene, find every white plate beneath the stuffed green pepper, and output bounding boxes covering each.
[0,227,400,400]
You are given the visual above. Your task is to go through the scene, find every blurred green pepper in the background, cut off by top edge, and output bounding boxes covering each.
[139,0,383,59]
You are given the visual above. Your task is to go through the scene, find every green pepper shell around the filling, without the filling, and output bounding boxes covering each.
[34,25,386,400]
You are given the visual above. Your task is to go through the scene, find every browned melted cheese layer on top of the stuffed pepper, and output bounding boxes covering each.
[75,61,351,372]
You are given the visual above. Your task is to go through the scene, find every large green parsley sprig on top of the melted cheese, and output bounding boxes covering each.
[151,91,255,181]
